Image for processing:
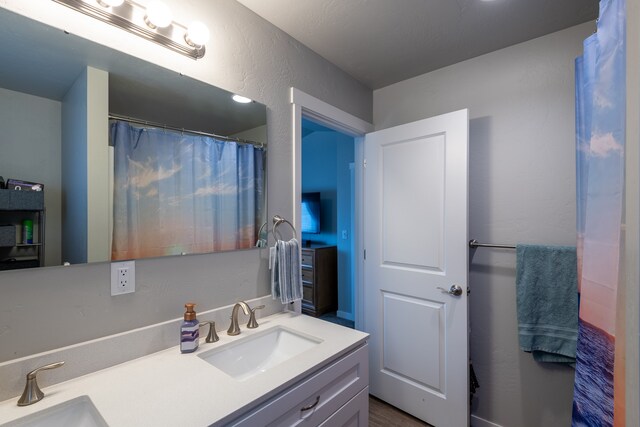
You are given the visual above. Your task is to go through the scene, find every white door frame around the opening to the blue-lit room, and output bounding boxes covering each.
[290,87,374,329]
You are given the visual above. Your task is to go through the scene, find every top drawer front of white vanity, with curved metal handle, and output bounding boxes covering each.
[230,344,369,427]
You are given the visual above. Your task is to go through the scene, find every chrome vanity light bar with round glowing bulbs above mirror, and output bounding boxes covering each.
[53,0,209,59]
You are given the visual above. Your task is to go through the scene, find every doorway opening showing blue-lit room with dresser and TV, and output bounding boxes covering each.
[300,115,356,328]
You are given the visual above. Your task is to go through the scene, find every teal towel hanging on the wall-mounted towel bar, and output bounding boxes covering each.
[516,245,578,365]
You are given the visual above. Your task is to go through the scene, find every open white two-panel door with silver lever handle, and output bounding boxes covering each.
[364,110,469,427]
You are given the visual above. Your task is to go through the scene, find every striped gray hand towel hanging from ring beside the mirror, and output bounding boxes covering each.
[271,239,302,304]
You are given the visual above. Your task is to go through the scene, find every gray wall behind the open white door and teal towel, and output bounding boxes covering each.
[374,24,594,427]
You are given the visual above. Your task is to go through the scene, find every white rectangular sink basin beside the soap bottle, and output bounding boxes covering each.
[199,326,322,381]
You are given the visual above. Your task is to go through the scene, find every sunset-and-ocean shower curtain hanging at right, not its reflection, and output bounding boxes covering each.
[572,0,626,427]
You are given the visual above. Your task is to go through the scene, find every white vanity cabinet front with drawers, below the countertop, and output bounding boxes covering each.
[224,343,369,427]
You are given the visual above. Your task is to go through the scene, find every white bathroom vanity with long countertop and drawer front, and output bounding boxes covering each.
[0,312,369,427]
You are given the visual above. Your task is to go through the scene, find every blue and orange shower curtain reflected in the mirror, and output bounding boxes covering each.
[110,121,264,260]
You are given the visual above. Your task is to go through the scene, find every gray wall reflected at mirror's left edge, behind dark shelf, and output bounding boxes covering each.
[0,88,61,266]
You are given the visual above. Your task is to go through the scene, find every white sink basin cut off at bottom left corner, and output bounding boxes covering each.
[2,396,108,427]
